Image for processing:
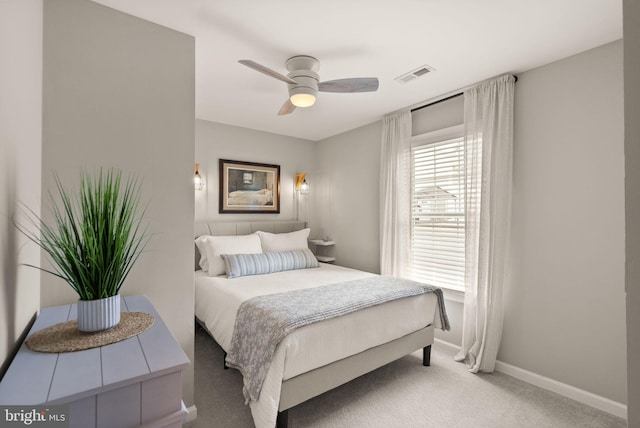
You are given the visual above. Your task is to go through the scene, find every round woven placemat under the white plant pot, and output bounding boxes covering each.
[26,312,154,352]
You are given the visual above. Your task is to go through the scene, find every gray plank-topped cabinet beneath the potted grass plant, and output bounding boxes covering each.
[0,296,189,428]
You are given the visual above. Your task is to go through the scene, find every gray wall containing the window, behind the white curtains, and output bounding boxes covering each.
[316,41,626,404]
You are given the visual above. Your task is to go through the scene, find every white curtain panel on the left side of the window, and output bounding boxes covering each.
[380,110,411,278]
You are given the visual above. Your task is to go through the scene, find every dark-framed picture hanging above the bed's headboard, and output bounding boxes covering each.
[218,159,280,214]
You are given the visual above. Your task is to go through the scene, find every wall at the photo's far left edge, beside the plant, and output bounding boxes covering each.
[0,0,42,376]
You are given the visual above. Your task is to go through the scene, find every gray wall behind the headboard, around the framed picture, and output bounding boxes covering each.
[195,119,316,223]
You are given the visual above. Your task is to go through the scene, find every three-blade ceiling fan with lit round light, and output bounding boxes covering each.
[238,55,378,116]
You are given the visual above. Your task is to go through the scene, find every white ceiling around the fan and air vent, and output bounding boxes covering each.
[94,0,622,140]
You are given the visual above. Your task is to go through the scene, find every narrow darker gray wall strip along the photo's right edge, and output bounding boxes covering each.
[623,0,640,422]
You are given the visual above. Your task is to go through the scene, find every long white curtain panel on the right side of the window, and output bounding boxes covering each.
[455,75,515,373]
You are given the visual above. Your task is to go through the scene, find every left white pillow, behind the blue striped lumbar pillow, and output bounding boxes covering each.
[204,233,262,276]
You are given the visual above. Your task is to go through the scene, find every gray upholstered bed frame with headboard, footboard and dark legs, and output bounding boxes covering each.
[194,221,433,428]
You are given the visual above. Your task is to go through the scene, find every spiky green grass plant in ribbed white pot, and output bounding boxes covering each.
[21,169,149,332]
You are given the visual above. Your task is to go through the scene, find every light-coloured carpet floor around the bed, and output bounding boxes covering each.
[185,328,627,428]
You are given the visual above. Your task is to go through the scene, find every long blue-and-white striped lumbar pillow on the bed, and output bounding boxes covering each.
[222,248,318,278]
